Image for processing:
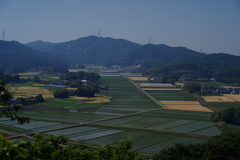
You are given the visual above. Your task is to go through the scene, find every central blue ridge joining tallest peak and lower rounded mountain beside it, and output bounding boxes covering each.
[26,36,205,65]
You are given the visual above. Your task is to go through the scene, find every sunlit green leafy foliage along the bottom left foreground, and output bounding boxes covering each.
[0,134,141,160]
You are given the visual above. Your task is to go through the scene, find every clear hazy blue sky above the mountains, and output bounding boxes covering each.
[0,0,240,56]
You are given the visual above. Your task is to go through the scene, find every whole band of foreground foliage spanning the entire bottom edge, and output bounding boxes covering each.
[0,133,240,160]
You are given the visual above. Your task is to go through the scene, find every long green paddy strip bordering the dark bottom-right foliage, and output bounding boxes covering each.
[137,137,206,154]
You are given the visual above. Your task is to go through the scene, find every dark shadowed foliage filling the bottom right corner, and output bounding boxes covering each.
[154,133,240,160]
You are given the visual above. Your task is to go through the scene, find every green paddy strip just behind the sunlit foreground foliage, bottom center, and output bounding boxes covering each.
[84,131,149,146]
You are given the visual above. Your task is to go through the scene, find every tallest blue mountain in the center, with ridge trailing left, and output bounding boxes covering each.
[26,36,141,65]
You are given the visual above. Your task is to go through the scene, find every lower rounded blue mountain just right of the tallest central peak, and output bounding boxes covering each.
[120,44,206,66]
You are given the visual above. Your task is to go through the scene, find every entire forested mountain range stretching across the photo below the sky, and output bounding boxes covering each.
[3,36,240,83]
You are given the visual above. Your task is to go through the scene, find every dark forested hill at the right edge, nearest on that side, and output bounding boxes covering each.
[142,53,240,84]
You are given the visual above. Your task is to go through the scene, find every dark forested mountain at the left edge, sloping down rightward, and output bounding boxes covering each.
[0,41,67,73]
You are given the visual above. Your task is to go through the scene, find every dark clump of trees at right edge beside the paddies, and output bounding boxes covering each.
[210,107,240,125]
